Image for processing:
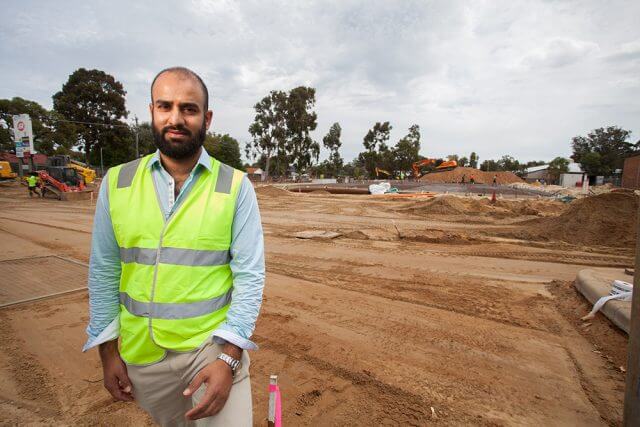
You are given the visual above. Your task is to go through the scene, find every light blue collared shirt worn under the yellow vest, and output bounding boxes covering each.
[83,149,264,351]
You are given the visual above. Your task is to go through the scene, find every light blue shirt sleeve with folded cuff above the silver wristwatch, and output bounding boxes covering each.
[213,176,265,350]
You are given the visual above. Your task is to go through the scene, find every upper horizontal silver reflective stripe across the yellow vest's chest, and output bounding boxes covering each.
[120,247,231,267]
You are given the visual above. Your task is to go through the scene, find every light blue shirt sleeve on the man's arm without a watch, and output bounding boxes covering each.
[82,172,121,351]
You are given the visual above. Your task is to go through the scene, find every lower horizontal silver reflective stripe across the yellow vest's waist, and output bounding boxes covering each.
[120,288,233,319]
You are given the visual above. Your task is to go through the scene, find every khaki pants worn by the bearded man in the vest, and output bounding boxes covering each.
[127,343,253,427]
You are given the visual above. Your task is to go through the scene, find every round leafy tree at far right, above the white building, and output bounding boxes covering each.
[571,126,640,176]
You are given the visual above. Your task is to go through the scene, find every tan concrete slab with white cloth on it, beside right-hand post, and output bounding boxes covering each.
[574,269,633,334]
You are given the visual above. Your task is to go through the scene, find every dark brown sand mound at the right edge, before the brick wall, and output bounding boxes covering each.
[527,192,638,248]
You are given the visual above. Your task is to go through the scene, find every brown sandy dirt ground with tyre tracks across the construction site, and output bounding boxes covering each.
[0,182,633,426]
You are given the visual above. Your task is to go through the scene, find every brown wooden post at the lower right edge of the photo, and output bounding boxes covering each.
[622,204,640,427]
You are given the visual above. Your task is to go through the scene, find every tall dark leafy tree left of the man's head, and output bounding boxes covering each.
[53,68,133,164]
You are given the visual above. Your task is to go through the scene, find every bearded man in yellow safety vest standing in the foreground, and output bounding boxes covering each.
[84,67,264,426]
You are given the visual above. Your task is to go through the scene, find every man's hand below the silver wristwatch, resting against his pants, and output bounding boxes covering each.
[183,360,233,420]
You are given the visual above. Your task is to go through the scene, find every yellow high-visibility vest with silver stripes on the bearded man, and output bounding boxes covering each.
[108,155,244,365]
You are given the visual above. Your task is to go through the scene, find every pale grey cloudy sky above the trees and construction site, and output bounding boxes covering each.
[0,0,640,161]
